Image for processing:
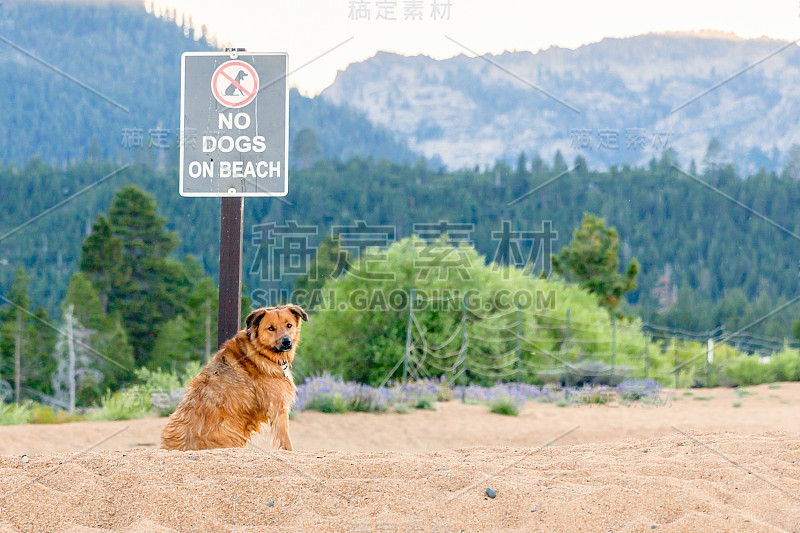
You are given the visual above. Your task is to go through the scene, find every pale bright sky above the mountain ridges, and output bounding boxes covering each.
[152,0,800,96]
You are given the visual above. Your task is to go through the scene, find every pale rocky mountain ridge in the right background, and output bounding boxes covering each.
[322,33,800,170]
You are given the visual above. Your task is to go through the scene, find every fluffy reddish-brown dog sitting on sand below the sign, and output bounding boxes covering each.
[161,305,308,450]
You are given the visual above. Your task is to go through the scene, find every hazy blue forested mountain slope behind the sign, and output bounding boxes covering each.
[0,0,418,166]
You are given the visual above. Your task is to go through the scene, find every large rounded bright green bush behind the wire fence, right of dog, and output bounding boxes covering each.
[301,237,648,386]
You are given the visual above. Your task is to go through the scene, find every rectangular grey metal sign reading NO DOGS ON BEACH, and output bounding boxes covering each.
[180,52,289,197]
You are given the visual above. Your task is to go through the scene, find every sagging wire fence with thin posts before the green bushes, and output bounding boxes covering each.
[390,290,800,388]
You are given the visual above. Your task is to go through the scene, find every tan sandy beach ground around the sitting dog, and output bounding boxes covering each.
[0,384,800,533]
